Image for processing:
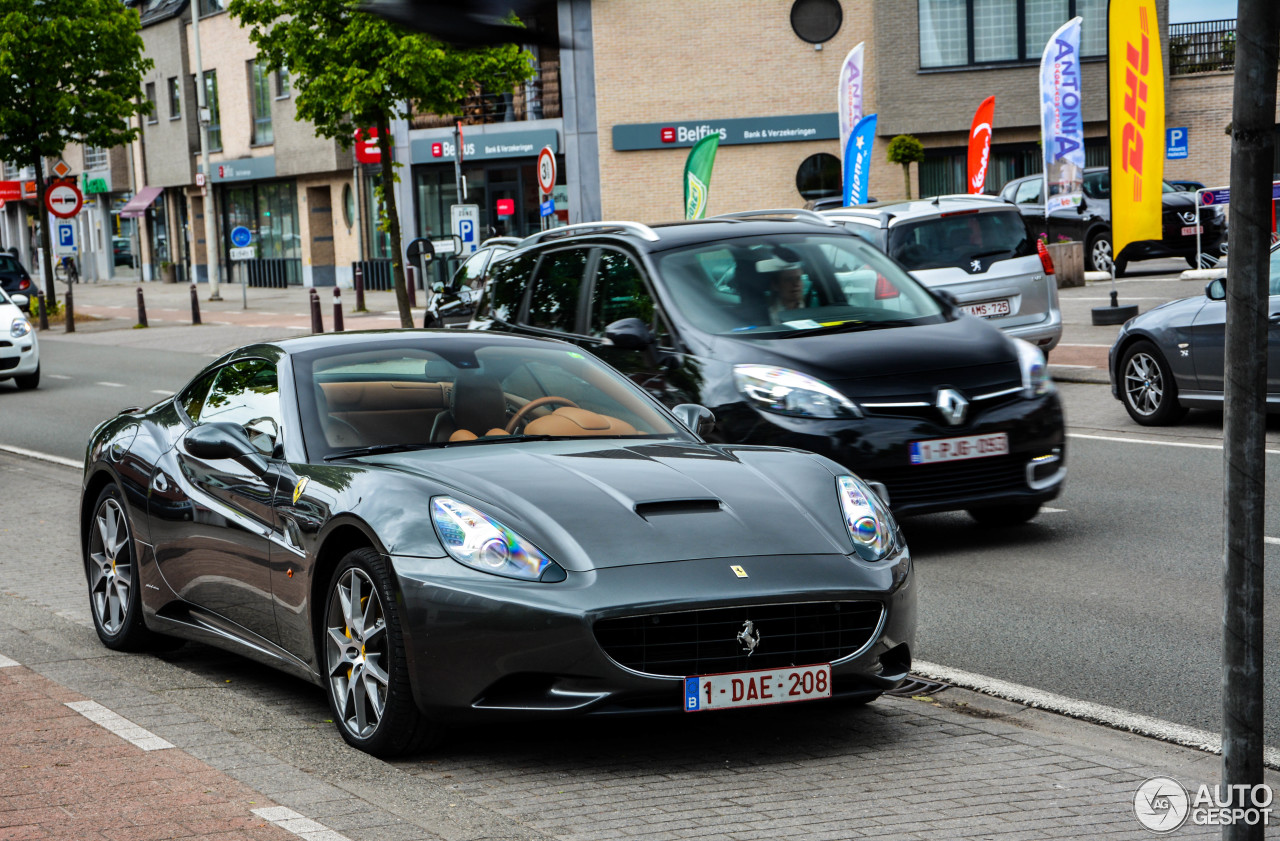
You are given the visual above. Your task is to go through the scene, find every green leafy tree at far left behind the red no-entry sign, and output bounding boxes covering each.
[0,0,152,305]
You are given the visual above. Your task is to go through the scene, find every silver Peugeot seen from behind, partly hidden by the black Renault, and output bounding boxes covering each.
[822,196,1062,355]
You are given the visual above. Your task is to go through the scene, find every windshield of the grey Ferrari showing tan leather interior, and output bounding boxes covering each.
[293,333,689,457]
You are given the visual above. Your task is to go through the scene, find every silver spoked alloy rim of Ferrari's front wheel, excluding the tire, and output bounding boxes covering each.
[325,567,390,739]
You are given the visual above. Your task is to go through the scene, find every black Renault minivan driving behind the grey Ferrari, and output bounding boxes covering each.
[470,210,1066,525]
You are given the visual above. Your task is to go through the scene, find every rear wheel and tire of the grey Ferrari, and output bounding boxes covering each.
[84,484,163,652]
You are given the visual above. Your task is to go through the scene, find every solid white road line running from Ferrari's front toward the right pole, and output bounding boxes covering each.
[911,661,1280,769]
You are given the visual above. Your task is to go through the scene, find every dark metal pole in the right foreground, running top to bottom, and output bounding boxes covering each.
[1222,0,1280,841]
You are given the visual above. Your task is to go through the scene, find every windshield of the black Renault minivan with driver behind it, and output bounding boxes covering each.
[658,234,945,338]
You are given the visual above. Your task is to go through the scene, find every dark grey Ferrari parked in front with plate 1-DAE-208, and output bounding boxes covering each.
[81,330,915,755]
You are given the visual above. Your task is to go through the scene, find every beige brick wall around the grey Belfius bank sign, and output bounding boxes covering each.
[591,0,885,221]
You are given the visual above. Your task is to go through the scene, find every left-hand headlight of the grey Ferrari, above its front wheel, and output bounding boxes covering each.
[431,497,563,581]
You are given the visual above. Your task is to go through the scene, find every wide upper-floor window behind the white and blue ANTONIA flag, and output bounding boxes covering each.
[916,0,1107,69]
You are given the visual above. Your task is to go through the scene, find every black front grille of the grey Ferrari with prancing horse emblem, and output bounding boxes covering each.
[595,602,884,677]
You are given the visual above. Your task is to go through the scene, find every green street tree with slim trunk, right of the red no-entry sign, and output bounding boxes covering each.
[228,0,532,326]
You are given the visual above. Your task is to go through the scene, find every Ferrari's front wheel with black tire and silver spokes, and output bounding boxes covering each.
[321,548,435,758]
